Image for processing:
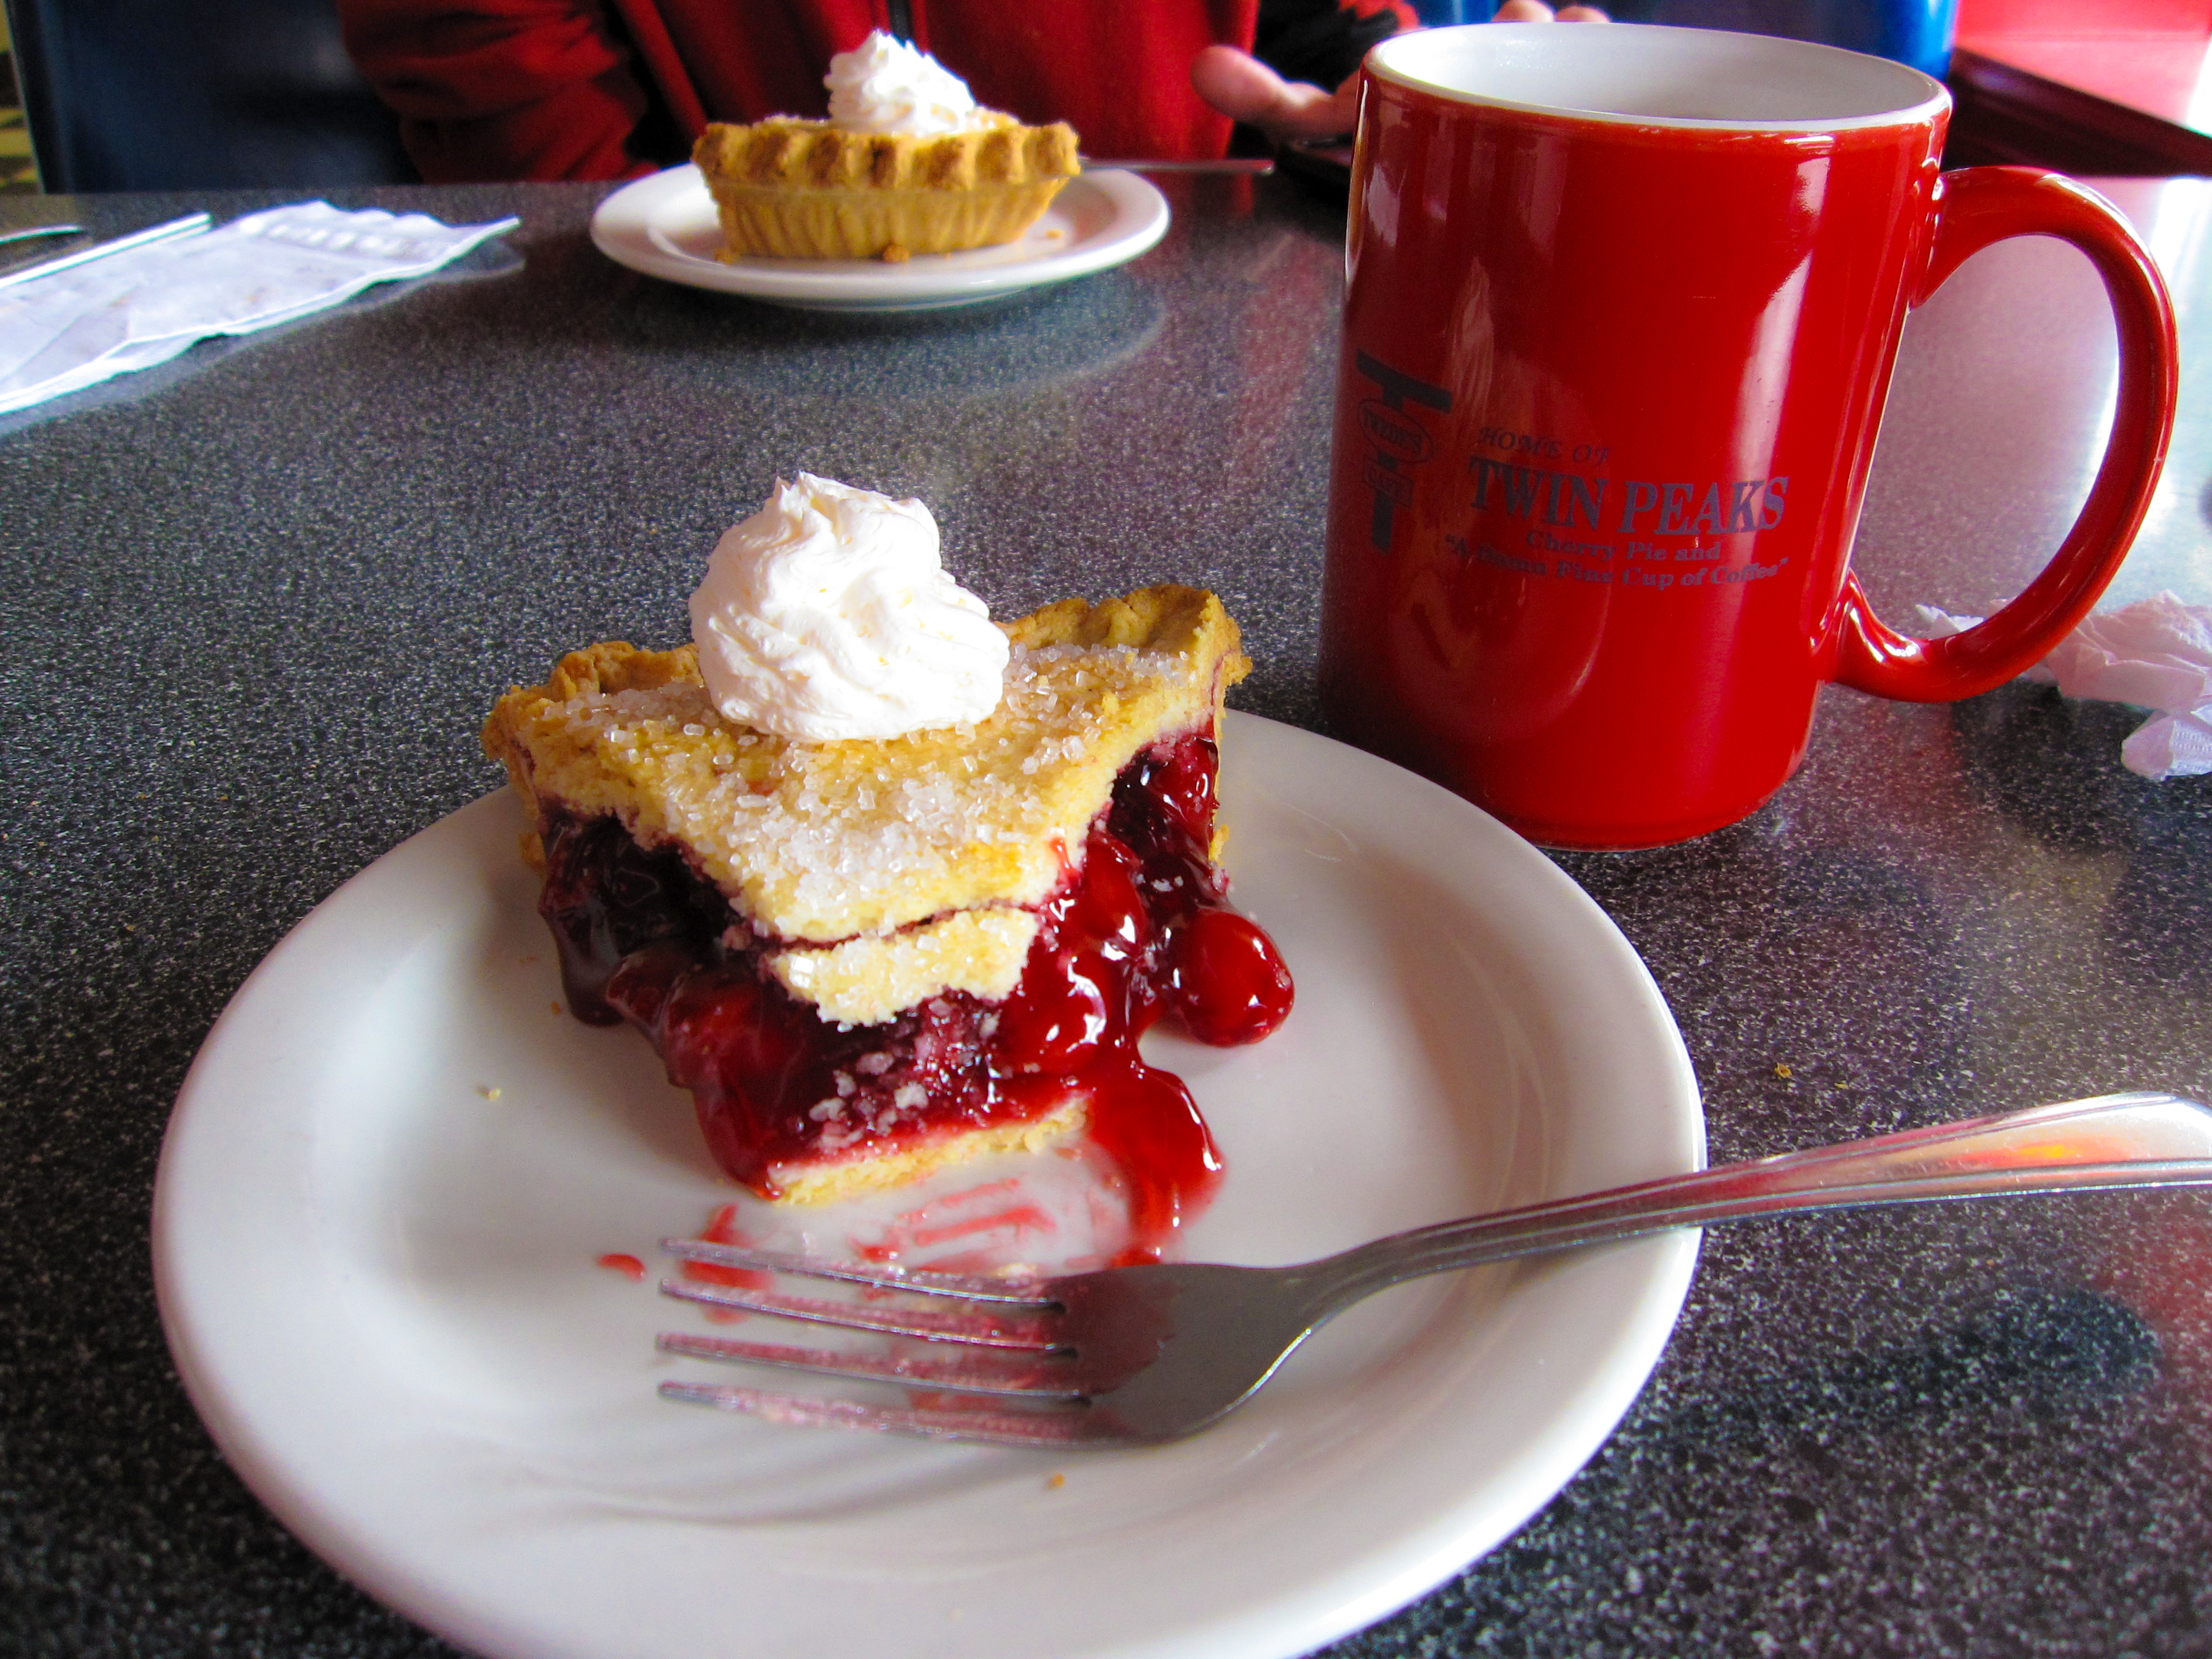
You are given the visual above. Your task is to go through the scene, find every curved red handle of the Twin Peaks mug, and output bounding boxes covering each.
[1829,168,2181,703]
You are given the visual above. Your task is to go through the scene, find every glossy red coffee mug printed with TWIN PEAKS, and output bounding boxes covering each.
[1321,24,2177,847]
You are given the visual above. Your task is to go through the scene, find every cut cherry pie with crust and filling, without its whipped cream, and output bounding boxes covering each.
[484,586,1292,1239]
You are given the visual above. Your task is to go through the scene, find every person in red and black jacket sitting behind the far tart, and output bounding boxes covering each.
[338,0,1601,184]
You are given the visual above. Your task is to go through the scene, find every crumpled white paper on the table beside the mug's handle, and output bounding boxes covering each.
[1915,593,2212,781]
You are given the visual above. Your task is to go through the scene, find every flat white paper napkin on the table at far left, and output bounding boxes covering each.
[0,201,518,414]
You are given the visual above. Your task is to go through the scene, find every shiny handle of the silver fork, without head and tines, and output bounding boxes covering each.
[1307,1093,2212,1312]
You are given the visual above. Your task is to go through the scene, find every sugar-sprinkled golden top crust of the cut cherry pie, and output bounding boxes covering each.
[484,586,1250,1024]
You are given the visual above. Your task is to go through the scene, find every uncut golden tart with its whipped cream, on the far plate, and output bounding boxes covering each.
[692,31,1082,263]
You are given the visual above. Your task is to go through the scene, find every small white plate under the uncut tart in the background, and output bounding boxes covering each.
[591,161,1168,312]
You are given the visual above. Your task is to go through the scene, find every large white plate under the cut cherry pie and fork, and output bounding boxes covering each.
[155,714,1703,1659]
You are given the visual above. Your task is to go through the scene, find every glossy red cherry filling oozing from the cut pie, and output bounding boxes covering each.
[537,734,1292,1247]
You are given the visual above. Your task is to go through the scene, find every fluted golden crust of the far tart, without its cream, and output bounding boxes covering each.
[692,110,1082,261]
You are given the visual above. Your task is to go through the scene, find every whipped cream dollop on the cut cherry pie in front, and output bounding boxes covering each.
[690,474,1008,743]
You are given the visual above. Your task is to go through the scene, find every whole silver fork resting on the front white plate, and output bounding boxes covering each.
[659,1093,2212,1447]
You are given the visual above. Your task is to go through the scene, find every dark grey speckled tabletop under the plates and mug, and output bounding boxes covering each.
[13,179,2212,1659]
